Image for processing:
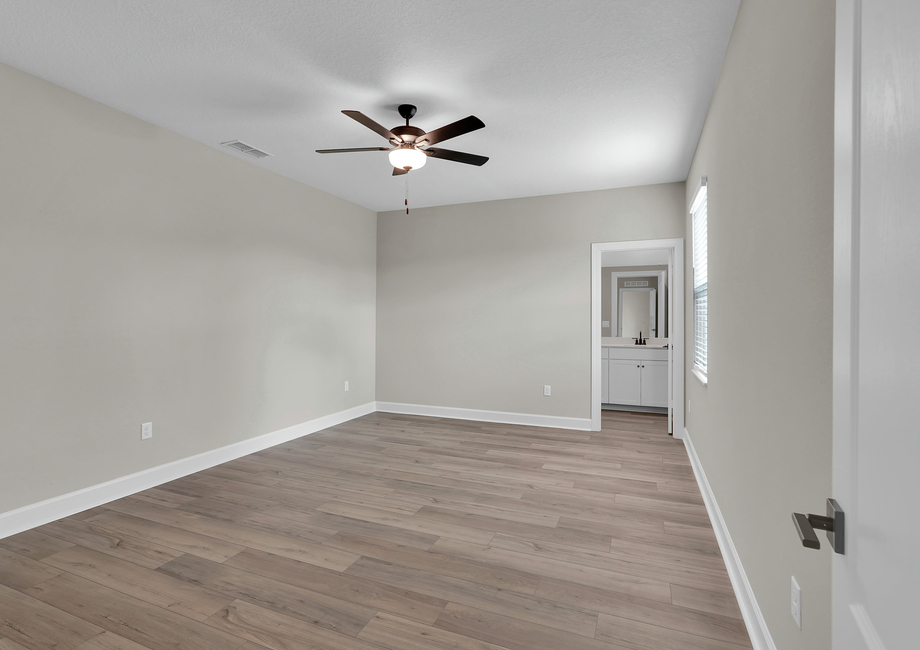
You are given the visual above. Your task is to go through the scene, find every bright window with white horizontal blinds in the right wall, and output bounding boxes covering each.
[690,176,709,385]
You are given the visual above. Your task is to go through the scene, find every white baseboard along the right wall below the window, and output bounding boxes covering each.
[683,429,776,650]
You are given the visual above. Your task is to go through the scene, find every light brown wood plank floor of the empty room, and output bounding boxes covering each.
[0,411,751,650]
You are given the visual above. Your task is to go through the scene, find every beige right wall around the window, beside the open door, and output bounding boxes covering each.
[685,0,834,650]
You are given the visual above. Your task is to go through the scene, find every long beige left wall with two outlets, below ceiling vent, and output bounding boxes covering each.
[0,65,376,512]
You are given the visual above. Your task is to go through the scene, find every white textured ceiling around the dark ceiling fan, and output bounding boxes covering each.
[0,0,739,211]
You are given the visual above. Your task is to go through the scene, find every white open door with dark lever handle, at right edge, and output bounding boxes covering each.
[832,0,920,650]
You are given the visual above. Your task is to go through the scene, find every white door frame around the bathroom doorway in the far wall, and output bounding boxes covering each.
[591,238,684,438]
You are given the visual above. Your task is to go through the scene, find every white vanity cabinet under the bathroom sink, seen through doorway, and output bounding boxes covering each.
[601,345,668,407]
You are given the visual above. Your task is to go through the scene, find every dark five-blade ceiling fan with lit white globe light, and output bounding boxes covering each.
[316,104,489,176]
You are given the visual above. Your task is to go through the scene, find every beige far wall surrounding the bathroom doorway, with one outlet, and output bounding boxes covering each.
[377,183,685,418]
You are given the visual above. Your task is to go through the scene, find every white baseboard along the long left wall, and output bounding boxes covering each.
[0,402,375,539]
